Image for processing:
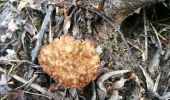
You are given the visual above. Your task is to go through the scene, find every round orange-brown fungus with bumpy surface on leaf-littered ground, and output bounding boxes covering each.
[38,35,100,88]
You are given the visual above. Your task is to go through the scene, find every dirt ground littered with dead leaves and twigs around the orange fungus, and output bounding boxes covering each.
[0,0,170,100]
